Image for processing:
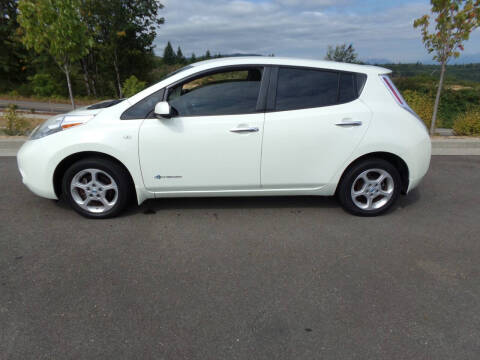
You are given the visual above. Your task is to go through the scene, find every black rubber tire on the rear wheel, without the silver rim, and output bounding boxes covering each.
[337,158,402,216]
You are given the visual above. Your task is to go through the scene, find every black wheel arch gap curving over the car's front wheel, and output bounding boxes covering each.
[53,151,138,198]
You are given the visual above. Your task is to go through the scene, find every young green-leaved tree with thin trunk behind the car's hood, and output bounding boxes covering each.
[18,0,93,108]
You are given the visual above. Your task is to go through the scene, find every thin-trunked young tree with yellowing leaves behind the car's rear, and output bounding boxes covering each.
[413,0,480,135]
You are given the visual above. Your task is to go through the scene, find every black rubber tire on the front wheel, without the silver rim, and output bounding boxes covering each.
[62,157,133,219]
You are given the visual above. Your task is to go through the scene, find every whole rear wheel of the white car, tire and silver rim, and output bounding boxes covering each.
[337,158,402,216]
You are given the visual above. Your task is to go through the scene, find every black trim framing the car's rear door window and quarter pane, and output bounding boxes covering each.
[265,65,368,113]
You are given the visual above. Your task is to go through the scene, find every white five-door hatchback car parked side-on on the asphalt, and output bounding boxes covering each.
[18,57,431,218]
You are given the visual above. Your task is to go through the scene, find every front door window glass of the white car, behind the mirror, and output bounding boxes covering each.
[167,68,262,116]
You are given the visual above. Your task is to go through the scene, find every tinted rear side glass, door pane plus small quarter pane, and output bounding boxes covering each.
[275,68,367,111]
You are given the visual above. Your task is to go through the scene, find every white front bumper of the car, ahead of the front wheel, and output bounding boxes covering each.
[17,139,58,199]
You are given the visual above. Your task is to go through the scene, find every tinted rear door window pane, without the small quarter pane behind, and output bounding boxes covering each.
[275,68,338,111]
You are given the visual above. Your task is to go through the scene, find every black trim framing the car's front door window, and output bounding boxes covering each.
[163,64,271,118]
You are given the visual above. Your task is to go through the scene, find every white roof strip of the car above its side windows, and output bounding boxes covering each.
[192,56,392,74]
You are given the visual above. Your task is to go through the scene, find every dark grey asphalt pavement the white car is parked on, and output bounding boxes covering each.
[0,156,480,360]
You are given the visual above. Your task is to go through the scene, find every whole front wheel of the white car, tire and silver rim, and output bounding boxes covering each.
[62,158,133,219]
